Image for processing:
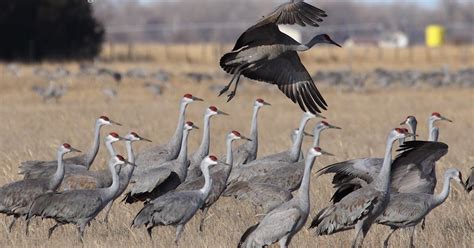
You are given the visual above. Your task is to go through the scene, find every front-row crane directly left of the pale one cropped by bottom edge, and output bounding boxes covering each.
[132,155,218,244]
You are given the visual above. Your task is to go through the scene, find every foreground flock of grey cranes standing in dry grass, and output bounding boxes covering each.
[0,94,474,247]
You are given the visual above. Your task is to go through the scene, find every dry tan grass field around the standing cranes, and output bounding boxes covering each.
[0,49,474,248]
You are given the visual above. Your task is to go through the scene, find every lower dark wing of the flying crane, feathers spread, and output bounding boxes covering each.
[242,51,327,113]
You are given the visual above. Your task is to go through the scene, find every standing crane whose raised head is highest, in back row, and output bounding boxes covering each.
[136,94,203,169]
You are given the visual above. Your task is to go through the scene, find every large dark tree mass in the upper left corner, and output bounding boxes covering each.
[0,0,104,61]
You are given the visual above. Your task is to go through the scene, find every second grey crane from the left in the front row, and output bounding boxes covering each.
[27,155,134,242]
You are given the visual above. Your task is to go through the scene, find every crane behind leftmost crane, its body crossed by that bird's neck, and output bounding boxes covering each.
[19,116,121,178]
